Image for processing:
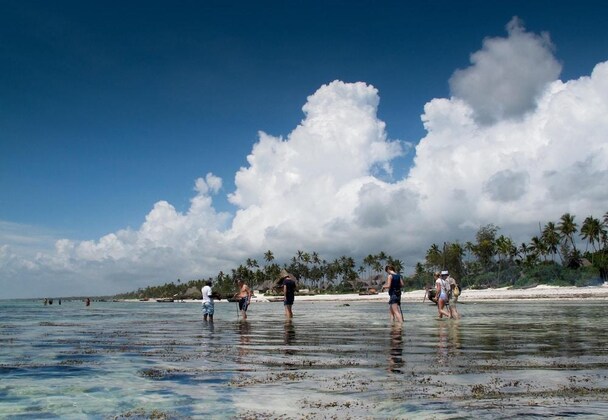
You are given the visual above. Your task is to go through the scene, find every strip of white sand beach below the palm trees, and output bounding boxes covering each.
[125,283,608,304]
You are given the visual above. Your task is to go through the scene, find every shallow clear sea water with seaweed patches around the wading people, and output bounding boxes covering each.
[0,301,608,419]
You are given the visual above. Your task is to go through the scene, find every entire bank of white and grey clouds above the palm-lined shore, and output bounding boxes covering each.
[0,19,608,296]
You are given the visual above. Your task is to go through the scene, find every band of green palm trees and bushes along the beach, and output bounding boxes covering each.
[115,212,608,299]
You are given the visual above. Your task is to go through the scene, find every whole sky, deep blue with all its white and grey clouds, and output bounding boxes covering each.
[0,0,608,298]
